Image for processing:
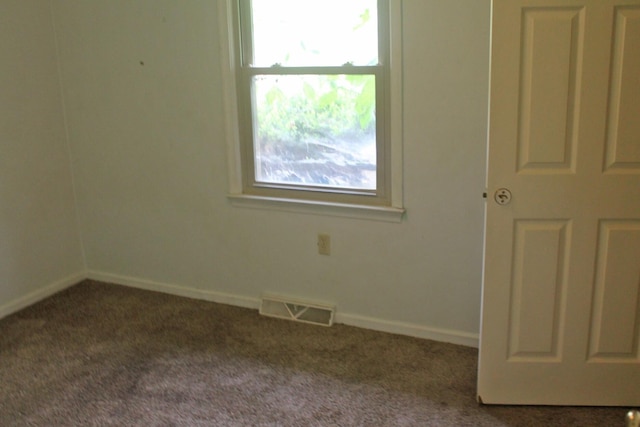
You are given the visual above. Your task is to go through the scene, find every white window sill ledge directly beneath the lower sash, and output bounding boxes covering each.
[228,194,405,222]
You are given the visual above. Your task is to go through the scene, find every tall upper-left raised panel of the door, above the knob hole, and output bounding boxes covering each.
[518,7,584,172]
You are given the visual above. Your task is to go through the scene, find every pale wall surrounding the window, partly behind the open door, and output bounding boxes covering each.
[53,0,489,345]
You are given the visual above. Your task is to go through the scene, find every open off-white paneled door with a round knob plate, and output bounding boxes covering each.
[478,0,640,406]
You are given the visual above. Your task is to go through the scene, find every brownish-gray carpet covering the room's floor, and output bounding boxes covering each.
[0,281,626,426]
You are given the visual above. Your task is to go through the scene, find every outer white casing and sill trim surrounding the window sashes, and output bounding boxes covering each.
[218,0,405,221]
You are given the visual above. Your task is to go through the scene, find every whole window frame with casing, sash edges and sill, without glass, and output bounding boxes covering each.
[219,0,405,222]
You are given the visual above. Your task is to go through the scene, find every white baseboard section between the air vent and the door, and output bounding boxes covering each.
[335,311,479,348]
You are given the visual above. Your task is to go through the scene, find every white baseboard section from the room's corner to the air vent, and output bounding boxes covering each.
[87,270,260,310]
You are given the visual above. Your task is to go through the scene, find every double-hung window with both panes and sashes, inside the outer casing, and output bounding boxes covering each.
[222,0,399,219]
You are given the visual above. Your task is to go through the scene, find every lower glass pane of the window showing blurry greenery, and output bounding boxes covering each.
[252,74,376,190]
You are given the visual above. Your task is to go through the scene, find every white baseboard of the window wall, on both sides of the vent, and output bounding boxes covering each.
[88,271,479,348]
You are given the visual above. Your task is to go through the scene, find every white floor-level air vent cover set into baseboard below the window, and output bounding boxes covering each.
[260,296,335,326]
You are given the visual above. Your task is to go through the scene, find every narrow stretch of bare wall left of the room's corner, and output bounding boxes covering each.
[0,0,84,317]
